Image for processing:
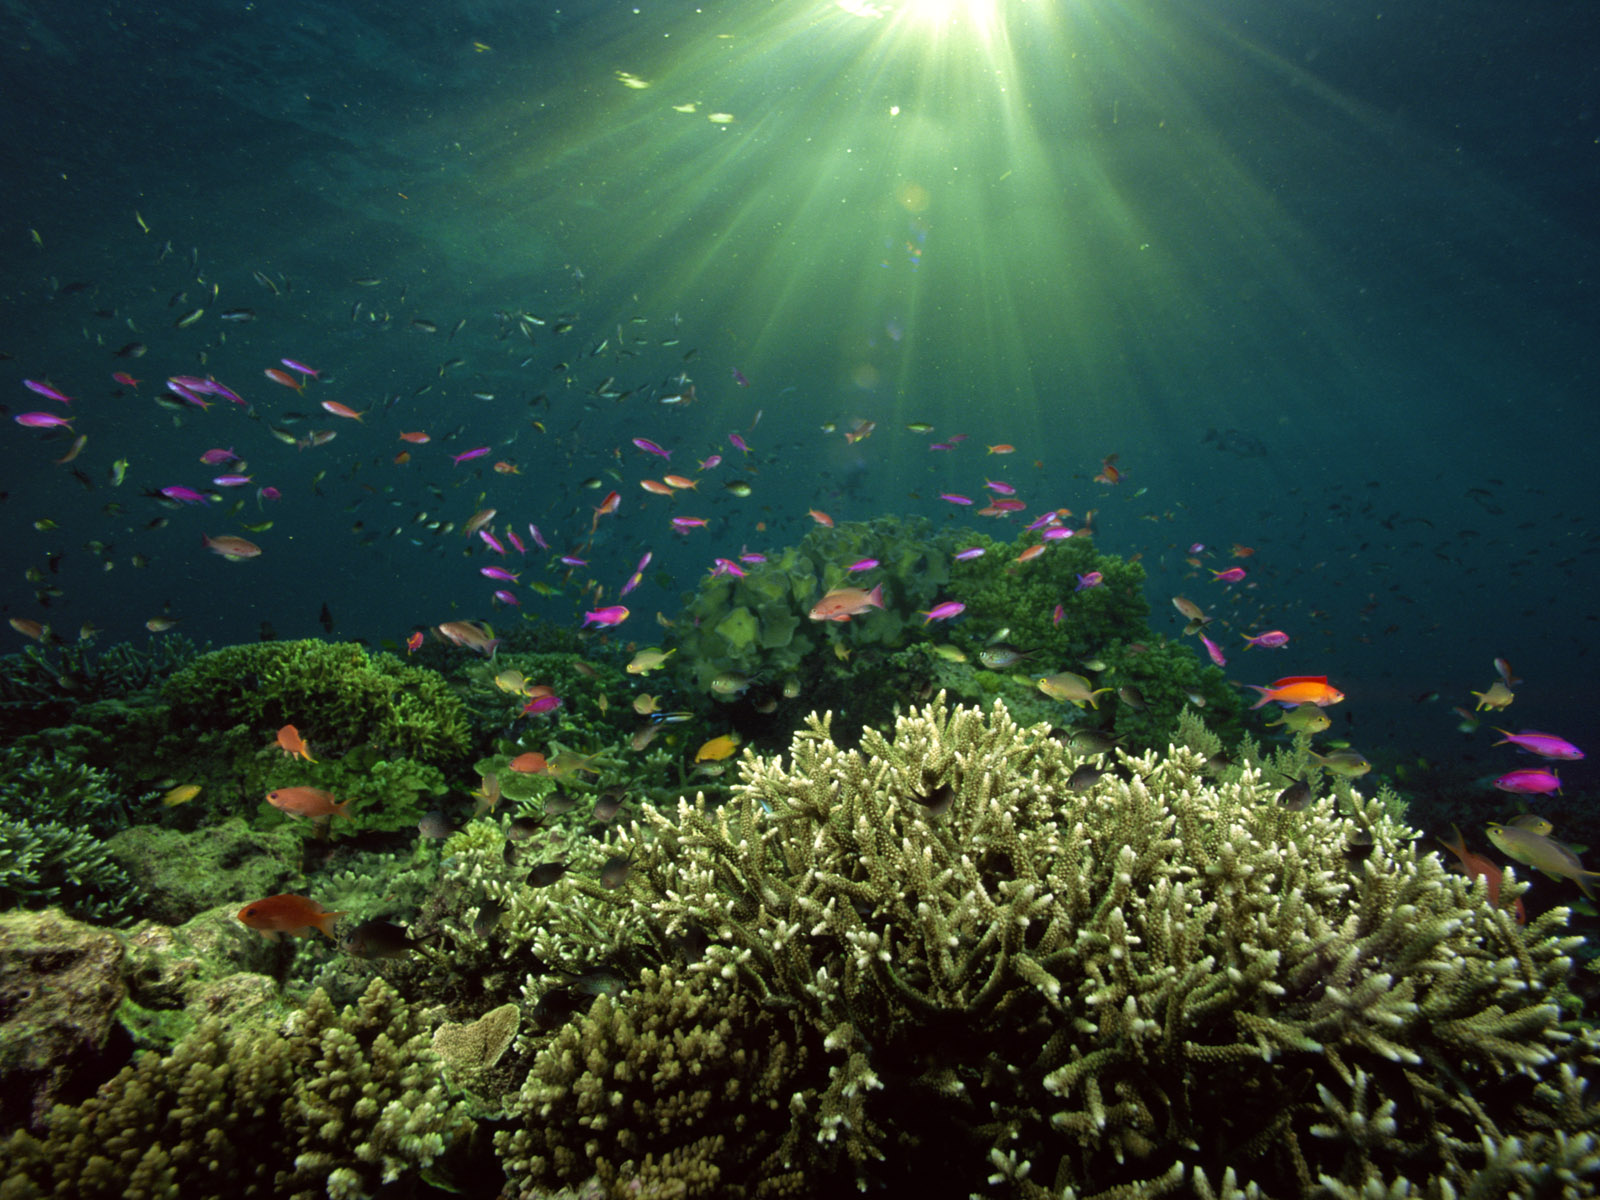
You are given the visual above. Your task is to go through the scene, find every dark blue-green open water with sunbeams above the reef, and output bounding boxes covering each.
[0,2,1600,806]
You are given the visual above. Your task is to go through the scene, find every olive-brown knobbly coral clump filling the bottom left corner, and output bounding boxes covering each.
[0,979,467,1200]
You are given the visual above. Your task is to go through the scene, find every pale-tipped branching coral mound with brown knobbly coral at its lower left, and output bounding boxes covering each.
[499,696,1600,1200]
